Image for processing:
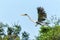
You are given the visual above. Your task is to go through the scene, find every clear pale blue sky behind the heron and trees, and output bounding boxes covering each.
[0,0,60,39]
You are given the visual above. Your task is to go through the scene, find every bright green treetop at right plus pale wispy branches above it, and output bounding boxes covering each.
[36,17,60,40]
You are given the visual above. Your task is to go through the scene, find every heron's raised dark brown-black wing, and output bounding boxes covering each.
[37,7,47,22]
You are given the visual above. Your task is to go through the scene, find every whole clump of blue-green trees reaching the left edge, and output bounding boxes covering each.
[0,23,21,40]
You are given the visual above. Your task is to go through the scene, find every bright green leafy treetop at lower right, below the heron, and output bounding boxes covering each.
[36,25,60,40]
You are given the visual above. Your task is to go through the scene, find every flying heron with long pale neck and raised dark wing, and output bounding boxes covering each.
[22,7,47,25]
